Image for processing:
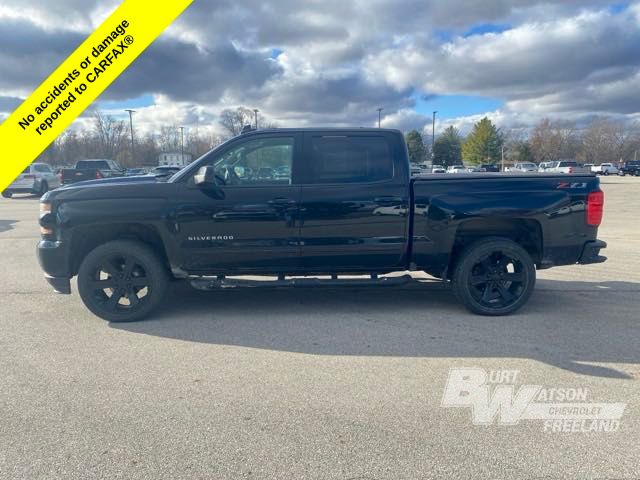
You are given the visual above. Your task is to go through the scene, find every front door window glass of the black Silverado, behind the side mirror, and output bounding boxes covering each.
[214,137,293,185]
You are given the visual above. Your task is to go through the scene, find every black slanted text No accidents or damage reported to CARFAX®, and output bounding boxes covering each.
[18,20,133,135]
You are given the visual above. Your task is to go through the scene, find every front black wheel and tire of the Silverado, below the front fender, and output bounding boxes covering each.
[78,240,169,322]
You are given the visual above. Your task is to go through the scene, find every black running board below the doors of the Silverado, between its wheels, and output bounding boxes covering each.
[191,275,413,290]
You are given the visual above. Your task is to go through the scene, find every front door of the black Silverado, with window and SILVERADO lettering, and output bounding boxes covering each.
[174,134,301,274]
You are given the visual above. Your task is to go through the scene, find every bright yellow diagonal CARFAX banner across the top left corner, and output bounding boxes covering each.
[0,0,193,191]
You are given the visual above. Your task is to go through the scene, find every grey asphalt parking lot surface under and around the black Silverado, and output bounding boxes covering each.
[0,177,640,480]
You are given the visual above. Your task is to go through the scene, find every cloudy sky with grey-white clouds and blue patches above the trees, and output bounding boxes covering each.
[0,0,640,137]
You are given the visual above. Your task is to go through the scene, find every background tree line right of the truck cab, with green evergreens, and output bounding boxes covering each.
[406,117,640,167]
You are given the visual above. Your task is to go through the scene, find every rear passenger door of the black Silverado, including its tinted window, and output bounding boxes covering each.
[300,131,409,272]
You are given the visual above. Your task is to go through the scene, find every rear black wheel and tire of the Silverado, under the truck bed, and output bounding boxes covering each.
[452,237,536,316]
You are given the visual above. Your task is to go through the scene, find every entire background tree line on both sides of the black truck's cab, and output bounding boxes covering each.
[37,107,640,167]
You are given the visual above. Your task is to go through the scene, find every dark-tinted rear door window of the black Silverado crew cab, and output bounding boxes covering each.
[309,136,393,183]
